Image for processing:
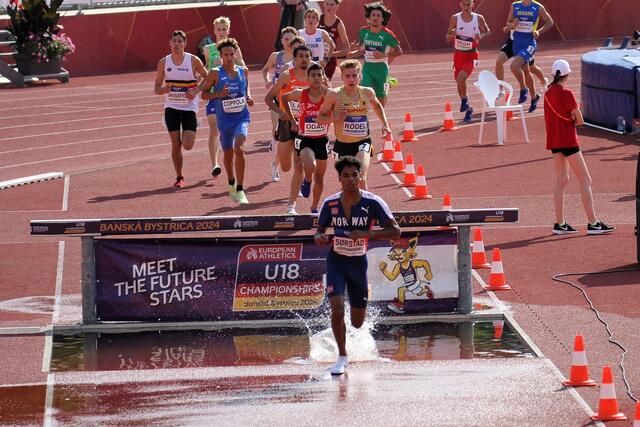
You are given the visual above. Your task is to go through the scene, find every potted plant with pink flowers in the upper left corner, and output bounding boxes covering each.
[7,0,75,75]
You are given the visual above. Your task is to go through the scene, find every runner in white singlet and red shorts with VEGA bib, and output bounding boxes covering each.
[445,0,491,123]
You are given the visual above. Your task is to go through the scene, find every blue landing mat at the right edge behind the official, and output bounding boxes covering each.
[581,49,640,131]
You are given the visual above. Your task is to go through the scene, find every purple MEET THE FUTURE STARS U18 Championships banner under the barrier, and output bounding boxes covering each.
[95,229,458,321]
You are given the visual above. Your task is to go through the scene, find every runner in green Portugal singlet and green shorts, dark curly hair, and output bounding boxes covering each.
[347,1,402,105]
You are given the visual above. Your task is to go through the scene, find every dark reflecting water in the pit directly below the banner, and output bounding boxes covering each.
[51,321,533,371]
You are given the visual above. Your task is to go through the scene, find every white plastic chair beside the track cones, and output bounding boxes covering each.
[474,70,529,145]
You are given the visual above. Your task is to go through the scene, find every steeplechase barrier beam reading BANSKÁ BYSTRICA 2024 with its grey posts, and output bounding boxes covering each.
[30,208,518,325]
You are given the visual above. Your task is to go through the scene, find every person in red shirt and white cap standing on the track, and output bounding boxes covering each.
[544,59,615,234]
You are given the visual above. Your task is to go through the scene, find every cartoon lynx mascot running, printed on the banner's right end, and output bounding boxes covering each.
[380,234,433,314]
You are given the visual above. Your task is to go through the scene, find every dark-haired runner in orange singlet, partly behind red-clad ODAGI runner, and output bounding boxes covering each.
[264,46,311,180]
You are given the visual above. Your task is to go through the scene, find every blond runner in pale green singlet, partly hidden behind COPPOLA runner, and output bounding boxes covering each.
[202,16,245,178]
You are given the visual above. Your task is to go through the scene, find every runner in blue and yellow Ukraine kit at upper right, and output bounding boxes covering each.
[506,0,553,112]
